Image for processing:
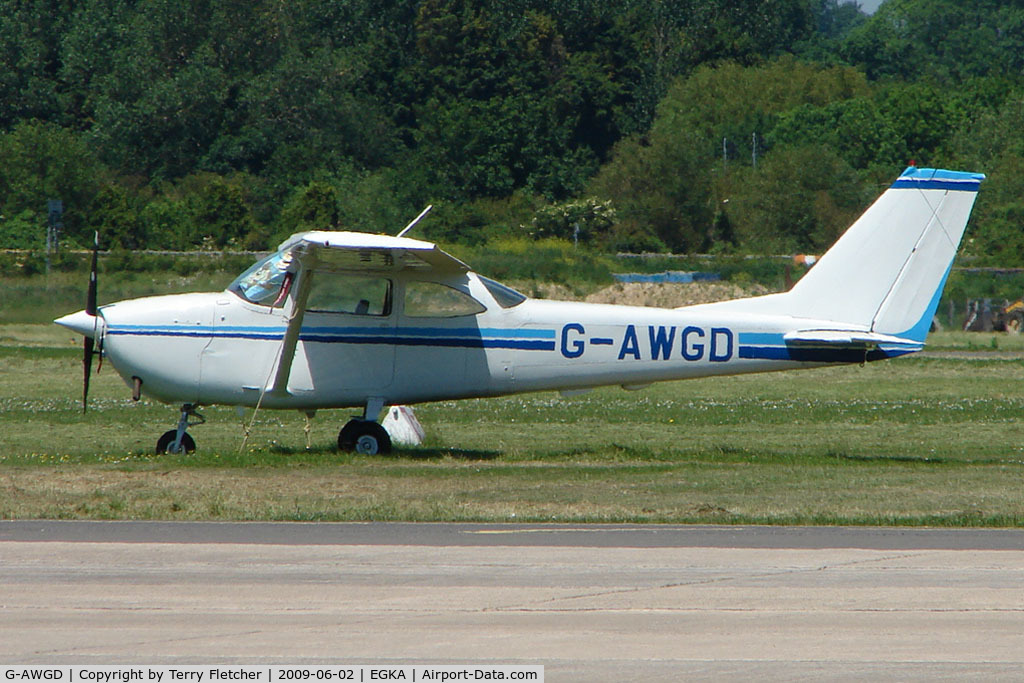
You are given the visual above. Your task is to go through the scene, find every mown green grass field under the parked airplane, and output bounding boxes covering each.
[6,325,1024,526]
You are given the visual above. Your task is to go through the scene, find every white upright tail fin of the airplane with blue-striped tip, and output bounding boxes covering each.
[696,166,985,343]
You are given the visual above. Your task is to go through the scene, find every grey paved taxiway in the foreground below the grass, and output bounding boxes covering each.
[0,521,1024,681]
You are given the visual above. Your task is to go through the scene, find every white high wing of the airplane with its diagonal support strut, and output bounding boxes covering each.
[265,230,469,394]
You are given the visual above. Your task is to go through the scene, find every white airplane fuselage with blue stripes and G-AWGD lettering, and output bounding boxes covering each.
[88,273,900,410]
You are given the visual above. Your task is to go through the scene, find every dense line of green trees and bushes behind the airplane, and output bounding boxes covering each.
[0,0,1024,264]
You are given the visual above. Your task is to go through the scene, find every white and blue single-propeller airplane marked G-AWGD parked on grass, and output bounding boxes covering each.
[56,166,985,454]
